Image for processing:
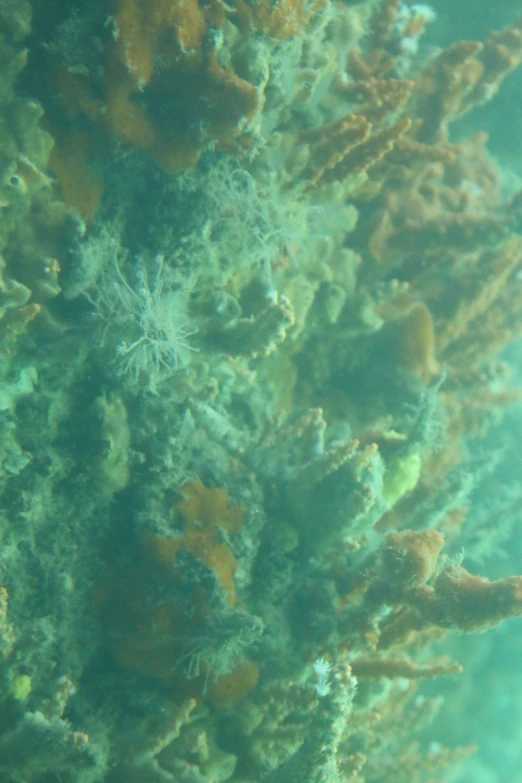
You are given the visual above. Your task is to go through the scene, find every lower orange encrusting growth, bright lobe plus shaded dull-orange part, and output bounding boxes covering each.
[98,481,248,676]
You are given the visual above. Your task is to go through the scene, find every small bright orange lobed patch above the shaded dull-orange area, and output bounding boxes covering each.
[145,481,246,606]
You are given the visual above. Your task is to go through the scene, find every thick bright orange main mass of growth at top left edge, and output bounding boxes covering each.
[105,0,261,172]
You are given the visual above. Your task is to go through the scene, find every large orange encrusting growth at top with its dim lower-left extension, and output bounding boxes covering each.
[47,0,262,219]
